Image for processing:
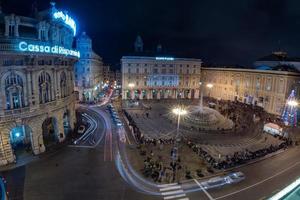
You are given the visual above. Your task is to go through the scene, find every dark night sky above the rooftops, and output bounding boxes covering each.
[2,0,300,69]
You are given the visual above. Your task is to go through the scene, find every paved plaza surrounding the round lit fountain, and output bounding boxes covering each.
[125,99,287,173]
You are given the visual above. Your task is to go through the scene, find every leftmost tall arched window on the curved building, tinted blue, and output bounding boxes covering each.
[5,72,25,109]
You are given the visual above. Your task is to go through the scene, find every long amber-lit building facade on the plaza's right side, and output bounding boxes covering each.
[201,67,300,115]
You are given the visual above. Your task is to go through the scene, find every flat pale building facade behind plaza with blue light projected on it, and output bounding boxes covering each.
[121,56,202,99]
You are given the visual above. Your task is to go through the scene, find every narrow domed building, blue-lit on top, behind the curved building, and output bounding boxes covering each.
[75,32,104,101]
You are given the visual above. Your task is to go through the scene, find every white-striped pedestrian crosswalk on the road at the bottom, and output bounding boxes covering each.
[158,183,189,200]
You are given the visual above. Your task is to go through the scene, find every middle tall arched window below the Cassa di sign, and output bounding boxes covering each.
[39,72,52,103]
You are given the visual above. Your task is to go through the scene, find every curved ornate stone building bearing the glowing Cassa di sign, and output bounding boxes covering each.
[0,3,80,165]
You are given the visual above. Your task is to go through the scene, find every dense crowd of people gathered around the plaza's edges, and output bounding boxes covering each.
[123,100,292,182]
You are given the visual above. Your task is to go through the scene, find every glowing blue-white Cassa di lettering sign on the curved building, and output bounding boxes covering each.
[19,41,80,58]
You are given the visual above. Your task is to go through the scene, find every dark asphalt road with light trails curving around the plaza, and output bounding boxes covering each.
[1,107,300,200]
